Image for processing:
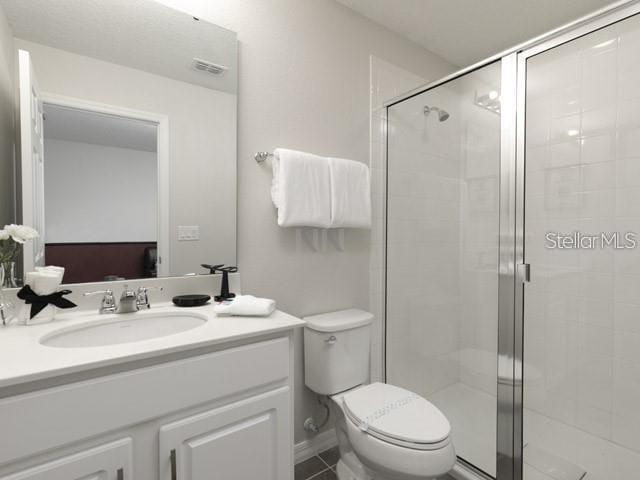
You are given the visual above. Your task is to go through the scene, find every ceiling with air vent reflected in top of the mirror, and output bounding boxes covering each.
[0,0,238,93]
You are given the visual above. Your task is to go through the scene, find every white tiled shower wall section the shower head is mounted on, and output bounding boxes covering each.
[386,79,462,395]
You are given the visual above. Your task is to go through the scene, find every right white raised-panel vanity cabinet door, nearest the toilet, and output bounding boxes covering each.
[160,387,292,480]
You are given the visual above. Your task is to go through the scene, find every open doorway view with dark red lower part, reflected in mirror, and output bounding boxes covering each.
[43,105,160,283]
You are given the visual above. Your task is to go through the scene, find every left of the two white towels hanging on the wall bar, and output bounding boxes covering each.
[271,148,331,228]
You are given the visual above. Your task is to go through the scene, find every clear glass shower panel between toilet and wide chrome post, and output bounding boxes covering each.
[386,62,501,476]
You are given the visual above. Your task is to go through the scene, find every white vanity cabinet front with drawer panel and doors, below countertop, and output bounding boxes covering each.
[0,331,293,480]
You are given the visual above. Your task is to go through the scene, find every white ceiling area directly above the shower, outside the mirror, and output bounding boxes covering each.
[337,0,614,67]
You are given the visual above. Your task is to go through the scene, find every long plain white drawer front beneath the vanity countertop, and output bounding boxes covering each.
[0,338,289,465]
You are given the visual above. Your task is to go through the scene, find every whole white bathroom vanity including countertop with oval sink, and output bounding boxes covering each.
[0,304,304,480]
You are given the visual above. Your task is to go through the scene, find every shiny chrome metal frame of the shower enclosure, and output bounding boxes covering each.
[382,0,640,480]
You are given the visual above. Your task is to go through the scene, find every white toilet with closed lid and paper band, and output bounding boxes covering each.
[304,309,456,480]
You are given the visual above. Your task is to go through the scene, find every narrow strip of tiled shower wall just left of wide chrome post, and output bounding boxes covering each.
[459,70,500,394]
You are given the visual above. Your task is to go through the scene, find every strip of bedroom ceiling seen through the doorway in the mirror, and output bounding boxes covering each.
[44,104,158,152]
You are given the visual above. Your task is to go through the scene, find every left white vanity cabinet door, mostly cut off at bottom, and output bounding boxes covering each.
[0,438,133,480]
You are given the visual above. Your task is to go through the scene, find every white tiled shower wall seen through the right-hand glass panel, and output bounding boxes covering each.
[524,18,640,452]
